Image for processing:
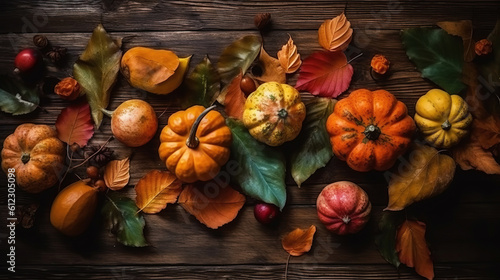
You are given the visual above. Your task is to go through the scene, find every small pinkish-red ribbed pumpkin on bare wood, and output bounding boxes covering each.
[316,181,372,235]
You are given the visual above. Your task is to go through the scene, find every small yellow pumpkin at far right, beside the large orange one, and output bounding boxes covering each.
[415,89,472,148]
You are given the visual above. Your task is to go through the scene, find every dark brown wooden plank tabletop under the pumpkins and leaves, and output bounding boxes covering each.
[0,0,500,280]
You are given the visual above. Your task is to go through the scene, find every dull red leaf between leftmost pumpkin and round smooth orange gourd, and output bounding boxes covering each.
[56,102,94,147]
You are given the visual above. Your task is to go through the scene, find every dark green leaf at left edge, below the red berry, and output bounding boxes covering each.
[0,75,40,115]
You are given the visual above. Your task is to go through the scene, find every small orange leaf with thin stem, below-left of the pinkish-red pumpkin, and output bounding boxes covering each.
[281,225,316,257]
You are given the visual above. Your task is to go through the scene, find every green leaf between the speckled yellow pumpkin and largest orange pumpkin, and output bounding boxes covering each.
[290,98,337,187]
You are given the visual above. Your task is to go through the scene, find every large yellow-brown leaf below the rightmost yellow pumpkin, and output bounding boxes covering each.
[385,144,455,211]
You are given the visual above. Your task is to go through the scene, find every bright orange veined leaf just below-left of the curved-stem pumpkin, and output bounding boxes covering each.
[135,170,182,214]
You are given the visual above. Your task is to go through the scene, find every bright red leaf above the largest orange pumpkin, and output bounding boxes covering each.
[295,51,354,98]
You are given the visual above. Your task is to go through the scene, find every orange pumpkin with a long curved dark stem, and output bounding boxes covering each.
[158,105,232,183]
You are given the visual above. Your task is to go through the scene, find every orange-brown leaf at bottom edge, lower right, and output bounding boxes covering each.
[396,220,434,280]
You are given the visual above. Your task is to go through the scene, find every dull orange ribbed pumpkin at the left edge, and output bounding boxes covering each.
[2,123,66,193]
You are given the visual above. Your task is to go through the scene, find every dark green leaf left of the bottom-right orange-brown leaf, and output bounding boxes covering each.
[375,212,403,268]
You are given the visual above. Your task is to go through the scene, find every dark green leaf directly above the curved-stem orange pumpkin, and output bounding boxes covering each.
[181,56,220,109]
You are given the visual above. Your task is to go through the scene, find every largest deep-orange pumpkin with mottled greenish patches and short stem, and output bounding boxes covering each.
[326,89,415,172]
